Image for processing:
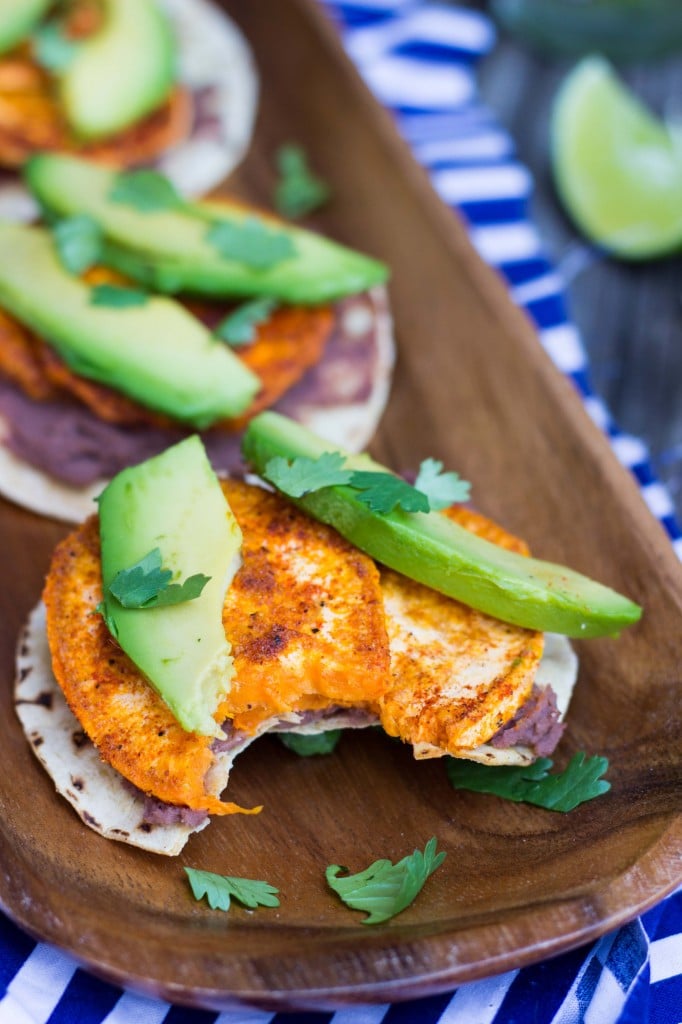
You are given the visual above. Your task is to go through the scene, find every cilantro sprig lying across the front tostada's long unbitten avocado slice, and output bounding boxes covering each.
[263,452,470,515]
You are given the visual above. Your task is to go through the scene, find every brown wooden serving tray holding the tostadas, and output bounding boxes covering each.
[0,0,682,1010]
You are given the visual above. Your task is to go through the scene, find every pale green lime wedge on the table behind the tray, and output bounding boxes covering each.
[552,56,682,259]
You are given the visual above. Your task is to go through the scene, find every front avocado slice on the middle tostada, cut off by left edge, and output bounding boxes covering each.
[0,222,260,429]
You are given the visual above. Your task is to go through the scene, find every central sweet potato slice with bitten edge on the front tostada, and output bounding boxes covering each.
[221,481,389,731]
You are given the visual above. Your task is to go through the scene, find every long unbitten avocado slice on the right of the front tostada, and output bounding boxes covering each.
[242,413,641,637]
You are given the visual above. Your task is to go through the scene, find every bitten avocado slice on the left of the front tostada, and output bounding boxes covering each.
[99,436,242,735]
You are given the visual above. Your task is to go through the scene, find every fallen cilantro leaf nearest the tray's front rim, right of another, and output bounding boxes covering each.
[326,837,445,925]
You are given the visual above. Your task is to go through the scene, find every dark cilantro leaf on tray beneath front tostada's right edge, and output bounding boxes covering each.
[446,753,611,812]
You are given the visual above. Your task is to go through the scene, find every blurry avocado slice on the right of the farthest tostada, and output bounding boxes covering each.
[59,0,176,139]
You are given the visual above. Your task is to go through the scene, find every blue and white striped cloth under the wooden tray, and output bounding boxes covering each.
[0,0,682,1024]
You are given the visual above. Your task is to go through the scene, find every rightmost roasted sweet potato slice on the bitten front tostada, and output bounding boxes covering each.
[380,507,544,757]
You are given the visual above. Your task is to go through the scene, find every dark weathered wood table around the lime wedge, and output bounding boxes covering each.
[470,6,682,520]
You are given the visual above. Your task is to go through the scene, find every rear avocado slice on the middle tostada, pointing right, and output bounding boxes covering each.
[25,153,388,305]
